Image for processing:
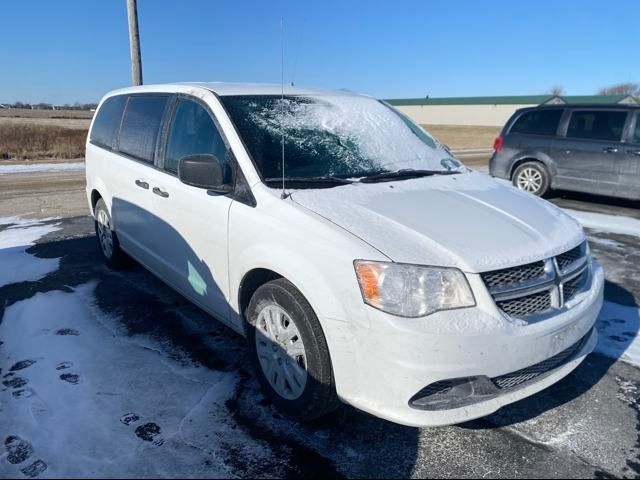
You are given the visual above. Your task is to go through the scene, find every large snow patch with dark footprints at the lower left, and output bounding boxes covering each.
[0,284,273,478]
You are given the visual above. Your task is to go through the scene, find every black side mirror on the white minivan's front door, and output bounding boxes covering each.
[178,155,233,195]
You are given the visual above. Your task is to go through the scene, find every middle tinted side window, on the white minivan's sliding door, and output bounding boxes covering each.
[118,95,169,163]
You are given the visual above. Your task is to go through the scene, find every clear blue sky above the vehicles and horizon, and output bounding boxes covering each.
[0,0,640,104]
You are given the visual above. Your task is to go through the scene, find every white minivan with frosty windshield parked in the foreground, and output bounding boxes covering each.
[86,83,604,426]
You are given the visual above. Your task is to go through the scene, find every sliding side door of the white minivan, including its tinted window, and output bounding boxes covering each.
[110,94,170,270]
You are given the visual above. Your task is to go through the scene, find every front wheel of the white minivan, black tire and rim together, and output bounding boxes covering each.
[246,278,340,421]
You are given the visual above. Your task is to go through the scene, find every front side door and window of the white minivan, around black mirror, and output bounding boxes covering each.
[150,96,232,320]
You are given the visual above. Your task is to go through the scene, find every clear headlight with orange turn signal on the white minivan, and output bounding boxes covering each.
[354,260,476,317]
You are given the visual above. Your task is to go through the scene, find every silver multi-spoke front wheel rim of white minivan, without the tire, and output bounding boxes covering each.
[256,304,308,400]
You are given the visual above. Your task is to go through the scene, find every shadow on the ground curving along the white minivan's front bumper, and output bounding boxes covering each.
[462,281,640,430]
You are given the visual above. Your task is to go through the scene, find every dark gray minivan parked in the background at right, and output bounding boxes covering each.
[490,105,640,200]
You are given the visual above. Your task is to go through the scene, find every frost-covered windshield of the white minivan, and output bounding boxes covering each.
[221,95,462,180]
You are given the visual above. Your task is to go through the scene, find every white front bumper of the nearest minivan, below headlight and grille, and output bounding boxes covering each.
[328,262,604,427]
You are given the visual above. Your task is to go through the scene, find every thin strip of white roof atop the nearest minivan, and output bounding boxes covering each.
[109,82,359,96]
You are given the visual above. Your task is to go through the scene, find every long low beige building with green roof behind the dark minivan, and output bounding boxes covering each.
[387,95,640,127]
